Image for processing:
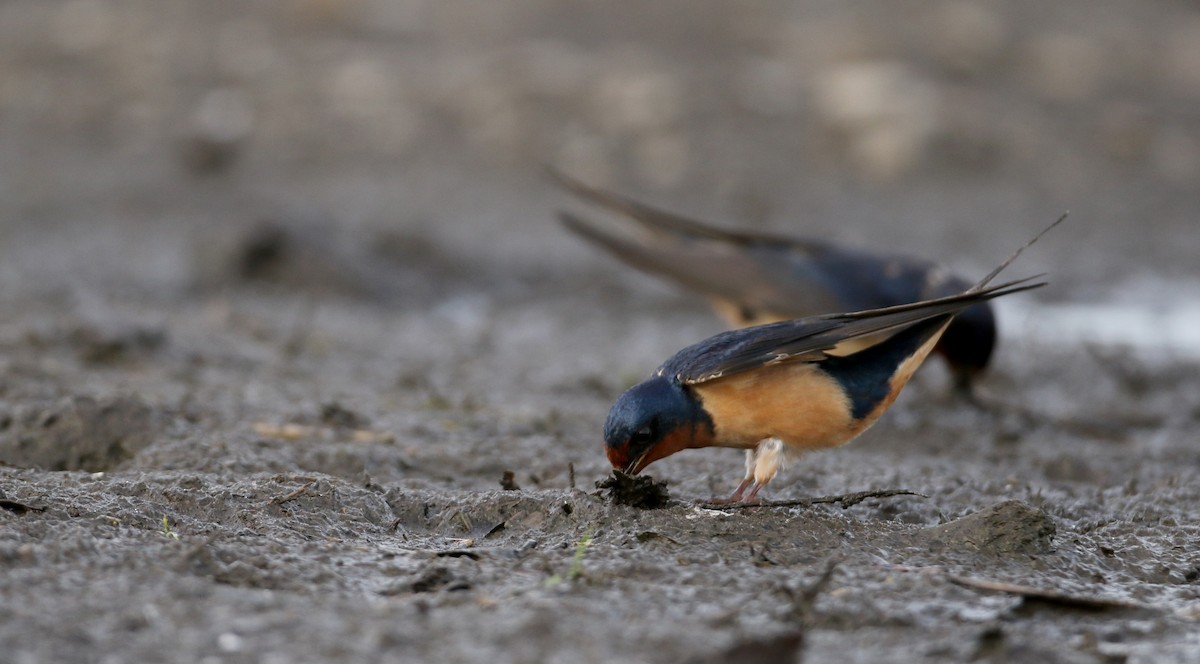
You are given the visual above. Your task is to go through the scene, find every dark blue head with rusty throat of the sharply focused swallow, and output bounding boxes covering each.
[604,376,713,474]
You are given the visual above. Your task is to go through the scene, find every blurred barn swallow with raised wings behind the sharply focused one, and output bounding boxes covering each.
[550,171,996,395]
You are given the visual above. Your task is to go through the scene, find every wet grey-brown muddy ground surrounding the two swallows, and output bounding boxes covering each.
[0,0,1200,663]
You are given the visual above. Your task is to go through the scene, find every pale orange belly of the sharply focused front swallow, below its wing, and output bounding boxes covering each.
[691,363,857,449]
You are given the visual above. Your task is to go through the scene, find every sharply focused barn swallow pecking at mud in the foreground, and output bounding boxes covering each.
[604,215,1066,502]
